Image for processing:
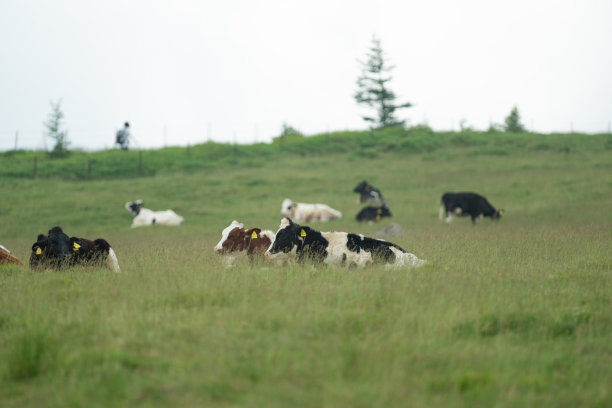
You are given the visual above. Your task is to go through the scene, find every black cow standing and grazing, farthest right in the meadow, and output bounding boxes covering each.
[439,193,504,225]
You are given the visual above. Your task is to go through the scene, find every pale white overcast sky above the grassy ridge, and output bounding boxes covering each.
[0,0,612,150]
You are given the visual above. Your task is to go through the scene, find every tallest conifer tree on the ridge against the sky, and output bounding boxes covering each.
[354,37,412,128]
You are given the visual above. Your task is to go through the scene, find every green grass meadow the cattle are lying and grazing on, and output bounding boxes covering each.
[0,135,612,407]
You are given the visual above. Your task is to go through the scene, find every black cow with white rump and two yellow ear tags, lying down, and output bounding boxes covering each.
[30,227,121,272]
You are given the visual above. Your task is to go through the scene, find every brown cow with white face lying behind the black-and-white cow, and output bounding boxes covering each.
[214,221,274,259]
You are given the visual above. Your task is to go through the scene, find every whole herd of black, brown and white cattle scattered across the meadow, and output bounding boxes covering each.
[0,181,503,272]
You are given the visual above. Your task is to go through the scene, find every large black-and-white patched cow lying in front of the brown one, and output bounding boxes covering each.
[266,218,426,267]
